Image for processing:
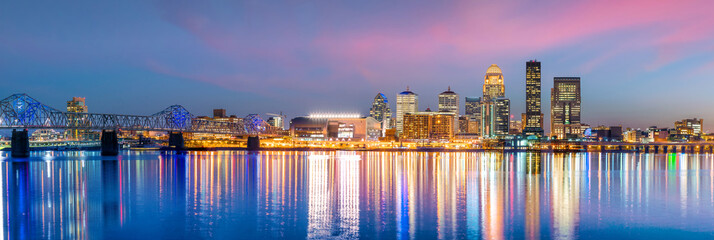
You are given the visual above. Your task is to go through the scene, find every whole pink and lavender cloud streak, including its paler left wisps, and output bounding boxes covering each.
[153,0,714,95]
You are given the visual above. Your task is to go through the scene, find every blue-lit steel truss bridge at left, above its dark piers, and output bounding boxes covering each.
[0,94,277,135]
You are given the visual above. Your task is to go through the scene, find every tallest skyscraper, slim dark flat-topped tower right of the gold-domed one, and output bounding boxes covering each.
[521,60,543,136]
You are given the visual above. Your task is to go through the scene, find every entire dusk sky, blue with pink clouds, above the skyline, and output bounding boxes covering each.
[0,0,714,131]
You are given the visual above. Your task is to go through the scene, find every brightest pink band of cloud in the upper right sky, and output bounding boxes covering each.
[315,1,714,71]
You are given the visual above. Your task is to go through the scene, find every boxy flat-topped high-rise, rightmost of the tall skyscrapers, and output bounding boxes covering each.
[550,77,582,139]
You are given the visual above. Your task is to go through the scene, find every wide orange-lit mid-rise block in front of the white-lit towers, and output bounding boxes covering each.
[401,112,456,140]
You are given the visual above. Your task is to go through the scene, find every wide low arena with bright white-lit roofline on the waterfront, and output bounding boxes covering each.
[290,115,382,141]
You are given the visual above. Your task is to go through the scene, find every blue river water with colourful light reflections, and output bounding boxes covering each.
[0,151,714,239]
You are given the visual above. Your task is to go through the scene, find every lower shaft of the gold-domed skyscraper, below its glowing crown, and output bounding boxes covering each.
[480,97,511,138]
